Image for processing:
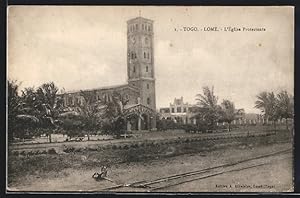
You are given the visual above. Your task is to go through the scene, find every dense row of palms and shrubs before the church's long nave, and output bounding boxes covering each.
[8,78,133,142]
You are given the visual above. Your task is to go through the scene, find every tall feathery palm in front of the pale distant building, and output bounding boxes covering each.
[196,86,221,129]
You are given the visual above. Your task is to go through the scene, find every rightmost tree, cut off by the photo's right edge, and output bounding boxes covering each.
[277,91,294,130]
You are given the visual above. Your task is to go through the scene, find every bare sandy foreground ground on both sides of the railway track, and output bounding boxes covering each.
[10,143,292,192]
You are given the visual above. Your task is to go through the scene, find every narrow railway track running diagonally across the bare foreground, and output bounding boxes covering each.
[100,149,292,192]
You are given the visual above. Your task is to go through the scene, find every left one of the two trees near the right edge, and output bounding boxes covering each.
[255,92,279,130]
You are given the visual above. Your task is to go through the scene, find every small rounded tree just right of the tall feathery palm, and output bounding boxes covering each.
[221,100,238,131]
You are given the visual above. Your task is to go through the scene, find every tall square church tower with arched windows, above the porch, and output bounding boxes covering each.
[127,17,156,111]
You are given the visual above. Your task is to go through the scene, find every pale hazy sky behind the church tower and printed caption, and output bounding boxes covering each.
[7,6,294,113]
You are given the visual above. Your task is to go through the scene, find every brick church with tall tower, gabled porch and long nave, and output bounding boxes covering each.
[63,17,156,130]
